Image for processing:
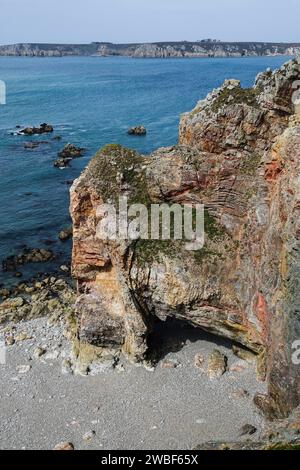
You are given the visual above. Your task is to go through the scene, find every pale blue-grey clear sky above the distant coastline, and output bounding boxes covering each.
[0,0,300,44]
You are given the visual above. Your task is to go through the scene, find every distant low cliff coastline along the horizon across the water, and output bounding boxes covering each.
[0,41,300,58]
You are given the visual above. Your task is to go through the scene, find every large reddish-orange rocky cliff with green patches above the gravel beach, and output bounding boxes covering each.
[71,61,300,417]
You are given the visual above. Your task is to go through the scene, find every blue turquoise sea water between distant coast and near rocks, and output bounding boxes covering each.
[0,57,288,282]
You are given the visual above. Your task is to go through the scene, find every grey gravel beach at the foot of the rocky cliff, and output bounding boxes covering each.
[0,318,265,450]
